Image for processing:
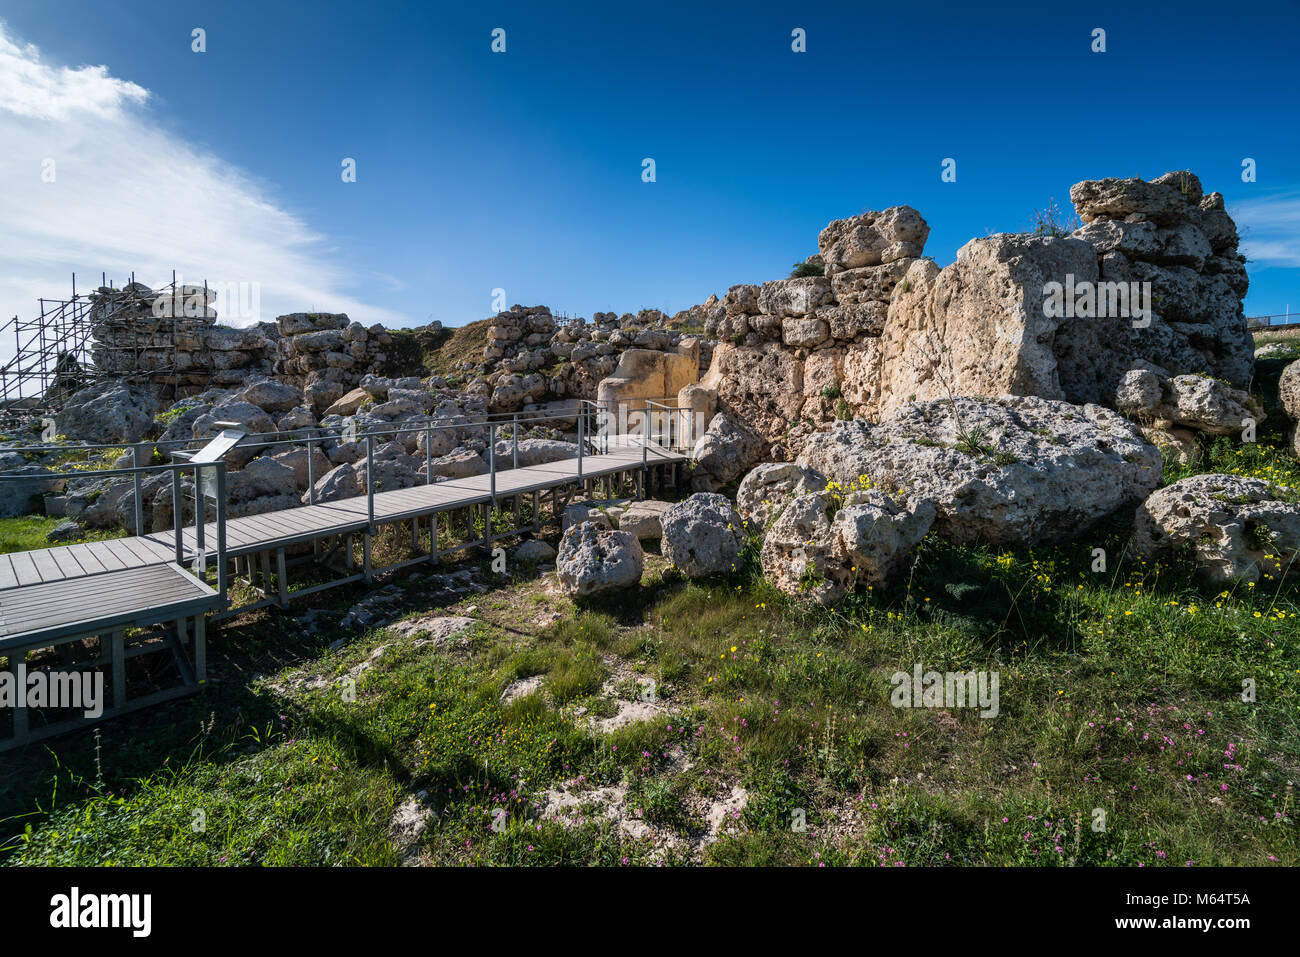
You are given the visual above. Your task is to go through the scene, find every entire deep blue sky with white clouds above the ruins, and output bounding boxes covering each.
[0,0,1300,325]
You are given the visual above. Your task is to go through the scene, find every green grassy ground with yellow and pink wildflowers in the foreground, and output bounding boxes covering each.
[0,439,1300,866]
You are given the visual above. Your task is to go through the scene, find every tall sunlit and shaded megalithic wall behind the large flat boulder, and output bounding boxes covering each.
[702,172,1253,458]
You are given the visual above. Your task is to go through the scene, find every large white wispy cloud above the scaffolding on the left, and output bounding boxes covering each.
[0,22,406,325]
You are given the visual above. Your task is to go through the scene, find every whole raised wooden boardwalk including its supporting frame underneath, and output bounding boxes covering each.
[0,441,686,750]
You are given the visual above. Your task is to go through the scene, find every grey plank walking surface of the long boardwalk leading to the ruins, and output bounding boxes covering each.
[0,445,686,595]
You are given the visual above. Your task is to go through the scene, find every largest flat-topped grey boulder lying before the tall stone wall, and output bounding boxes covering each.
[798,395,1161,545]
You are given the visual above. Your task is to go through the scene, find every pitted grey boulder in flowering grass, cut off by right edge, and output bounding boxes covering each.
[1130,475,1300,581]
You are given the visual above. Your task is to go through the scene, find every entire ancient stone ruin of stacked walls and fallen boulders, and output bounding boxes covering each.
[10,172,1300,601]
